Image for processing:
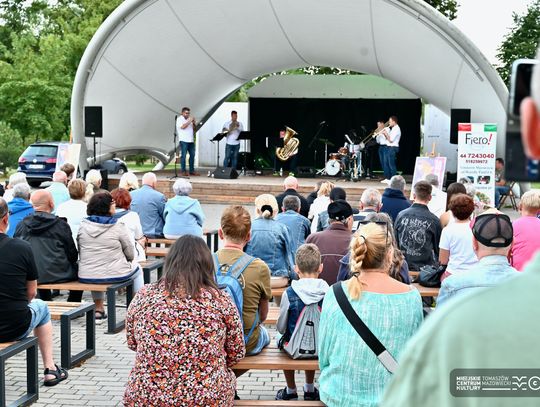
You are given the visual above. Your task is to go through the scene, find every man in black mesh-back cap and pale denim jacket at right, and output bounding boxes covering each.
[437,210,517,306]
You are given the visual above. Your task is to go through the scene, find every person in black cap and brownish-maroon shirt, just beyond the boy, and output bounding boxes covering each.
[306,201,353,285]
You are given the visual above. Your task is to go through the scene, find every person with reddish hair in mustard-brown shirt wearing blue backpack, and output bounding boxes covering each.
[214,206,272,355]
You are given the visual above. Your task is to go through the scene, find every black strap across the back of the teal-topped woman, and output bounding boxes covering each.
[332,282,398,373]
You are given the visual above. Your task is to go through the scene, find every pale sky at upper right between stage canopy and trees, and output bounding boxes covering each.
[453,0,532,65]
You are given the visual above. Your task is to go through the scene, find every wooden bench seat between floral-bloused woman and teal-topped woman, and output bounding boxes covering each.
[233,344,319,370]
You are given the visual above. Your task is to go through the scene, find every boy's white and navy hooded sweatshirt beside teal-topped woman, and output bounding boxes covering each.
[276,278,329,335]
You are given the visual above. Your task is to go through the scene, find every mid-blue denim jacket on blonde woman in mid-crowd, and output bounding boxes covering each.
[246,218,294,277]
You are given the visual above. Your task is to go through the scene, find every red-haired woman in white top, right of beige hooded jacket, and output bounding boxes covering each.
[111,188,146,262]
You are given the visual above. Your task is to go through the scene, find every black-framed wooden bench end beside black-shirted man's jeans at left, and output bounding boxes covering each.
[46,301,96,369]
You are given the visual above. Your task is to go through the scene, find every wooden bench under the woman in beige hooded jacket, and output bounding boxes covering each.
[38,279,133,334]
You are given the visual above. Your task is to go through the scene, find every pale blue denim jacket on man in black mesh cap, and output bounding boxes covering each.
[437,255,519,306]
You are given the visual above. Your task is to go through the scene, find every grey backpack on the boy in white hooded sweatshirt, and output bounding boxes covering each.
[283,303,321,359]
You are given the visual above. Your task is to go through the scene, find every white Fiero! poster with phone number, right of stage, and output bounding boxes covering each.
[457,123,497,206]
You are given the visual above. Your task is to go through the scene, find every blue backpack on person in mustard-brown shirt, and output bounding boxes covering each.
[213,253,259,344]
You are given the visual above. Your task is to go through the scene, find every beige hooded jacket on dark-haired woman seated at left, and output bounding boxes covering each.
[77,216,137,283]
